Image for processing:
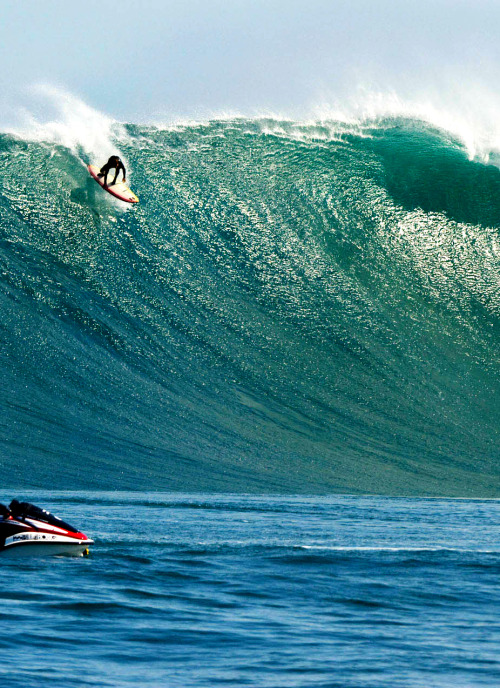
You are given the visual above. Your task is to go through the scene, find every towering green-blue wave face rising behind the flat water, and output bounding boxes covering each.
[0,118,500,496]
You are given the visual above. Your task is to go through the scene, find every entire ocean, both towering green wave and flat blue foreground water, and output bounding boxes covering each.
[0,108,500,688]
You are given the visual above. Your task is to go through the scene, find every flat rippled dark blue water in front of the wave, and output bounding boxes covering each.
[0,492,500,688]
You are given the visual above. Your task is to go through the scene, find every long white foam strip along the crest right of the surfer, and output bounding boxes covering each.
[147,83,500,162]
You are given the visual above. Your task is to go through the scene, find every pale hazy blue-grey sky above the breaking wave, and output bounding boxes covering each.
[0,0,500,120]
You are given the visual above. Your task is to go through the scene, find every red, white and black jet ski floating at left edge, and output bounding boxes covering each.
[0,499,94,557]
